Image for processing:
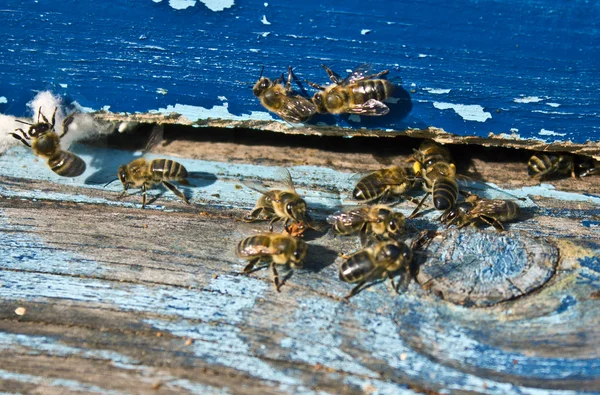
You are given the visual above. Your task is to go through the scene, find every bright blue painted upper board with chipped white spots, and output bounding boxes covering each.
[0,0,600,143]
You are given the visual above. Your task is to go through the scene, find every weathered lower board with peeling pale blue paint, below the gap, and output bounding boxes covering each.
[0,135,600,394]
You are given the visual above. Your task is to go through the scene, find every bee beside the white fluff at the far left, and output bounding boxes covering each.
[10,107,86,177]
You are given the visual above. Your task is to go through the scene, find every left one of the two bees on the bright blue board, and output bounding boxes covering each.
[252,66,316,123]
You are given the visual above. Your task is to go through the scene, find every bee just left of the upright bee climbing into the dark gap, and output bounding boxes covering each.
[352,166,415,203]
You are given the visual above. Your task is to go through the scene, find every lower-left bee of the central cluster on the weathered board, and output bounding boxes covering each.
[235,233,308,292]
